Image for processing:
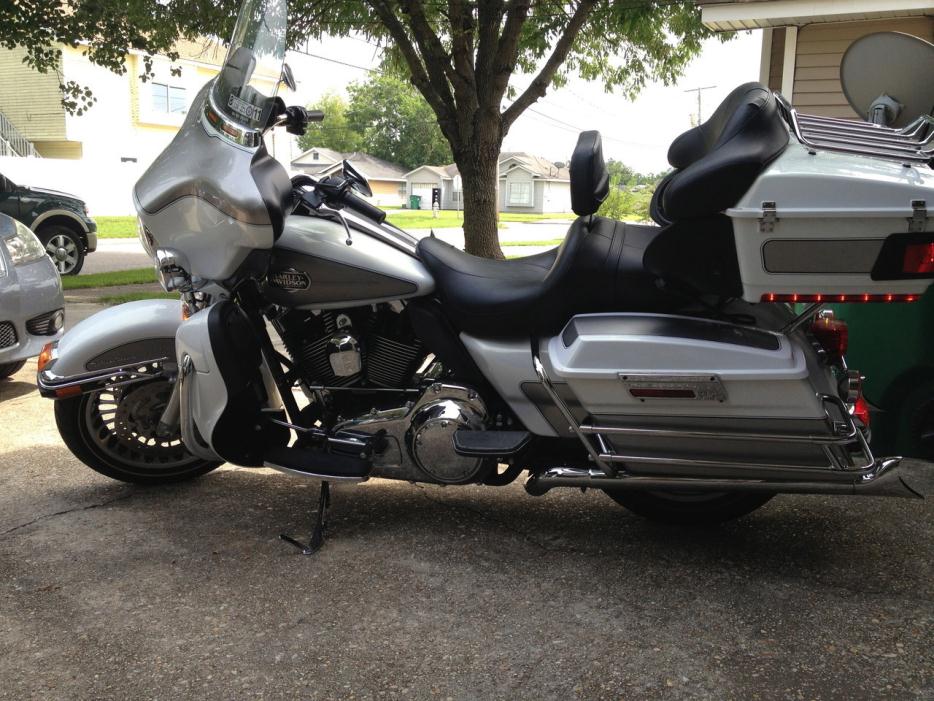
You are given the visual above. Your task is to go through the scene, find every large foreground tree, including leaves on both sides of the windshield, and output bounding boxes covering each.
[0,0,711,257]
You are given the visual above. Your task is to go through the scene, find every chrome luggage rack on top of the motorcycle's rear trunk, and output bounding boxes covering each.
[774,93,934,165]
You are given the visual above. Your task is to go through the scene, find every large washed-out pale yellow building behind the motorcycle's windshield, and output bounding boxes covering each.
[0,39,286,215]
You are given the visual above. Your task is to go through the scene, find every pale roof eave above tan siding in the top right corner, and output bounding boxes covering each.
[694,0,931,31]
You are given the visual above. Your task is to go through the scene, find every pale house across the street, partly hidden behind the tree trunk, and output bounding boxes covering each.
[405,152,571,214]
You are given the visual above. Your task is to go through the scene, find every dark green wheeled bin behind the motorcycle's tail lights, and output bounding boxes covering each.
[831,287,934,460]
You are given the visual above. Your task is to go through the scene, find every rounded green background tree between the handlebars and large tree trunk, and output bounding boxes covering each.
[350,75,451,170]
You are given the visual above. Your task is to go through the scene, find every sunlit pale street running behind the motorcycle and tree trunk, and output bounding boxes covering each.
[81,220,570,274]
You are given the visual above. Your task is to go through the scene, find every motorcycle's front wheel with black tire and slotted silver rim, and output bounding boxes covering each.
[55,379,220,485]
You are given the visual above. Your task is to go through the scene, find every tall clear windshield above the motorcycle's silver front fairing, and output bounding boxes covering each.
[214,0,288,129]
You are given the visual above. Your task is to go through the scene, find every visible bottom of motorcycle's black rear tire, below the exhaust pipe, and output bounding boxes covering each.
[605,490,775,526]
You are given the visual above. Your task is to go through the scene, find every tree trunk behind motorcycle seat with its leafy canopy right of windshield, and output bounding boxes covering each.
[310,0,711,257]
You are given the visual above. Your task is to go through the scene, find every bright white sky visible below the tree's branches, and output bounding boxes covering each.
[283,31,762,173]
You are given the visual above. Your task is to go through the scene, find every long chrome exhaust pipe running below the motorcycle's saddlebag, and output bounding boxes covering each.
[525,458,932,499]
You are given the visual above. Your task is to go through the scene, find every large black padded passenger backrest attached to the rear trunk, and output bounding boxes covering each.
[652,83,788,224]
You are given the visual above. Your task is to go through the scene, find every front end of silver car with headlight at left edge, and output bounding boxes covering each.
[0,214,65,378]
